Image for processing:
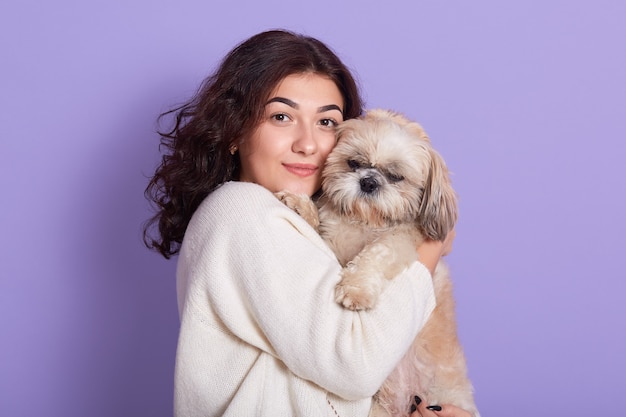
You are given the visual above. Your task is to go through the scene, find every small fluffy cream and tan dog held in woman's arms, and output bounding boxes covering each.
[277,110,479,417]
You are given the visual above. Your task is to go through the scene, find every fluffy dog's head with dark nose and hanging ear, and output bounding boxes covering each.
[322,110,457,240]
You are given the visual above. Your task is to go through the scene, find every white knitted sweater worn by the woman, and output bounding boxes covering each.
[174,182,435,417]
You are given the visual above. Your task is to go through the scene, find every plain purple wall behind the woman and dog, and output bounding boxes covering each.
[0,0,626,417]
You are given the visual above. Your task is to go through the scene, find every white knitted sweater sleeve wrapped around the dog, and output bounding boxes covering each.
[178,183,435,400]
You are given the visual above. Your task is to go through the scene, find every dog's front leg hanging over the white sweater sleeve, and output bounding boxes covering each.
[335,231,418,310]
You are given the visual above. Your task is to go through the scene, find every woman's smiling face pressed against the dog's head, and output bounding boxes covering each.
[239,73,344,196]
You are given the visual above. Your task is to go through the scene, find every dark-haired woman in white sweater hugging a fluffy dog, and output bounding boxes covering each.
[145,31,469,417]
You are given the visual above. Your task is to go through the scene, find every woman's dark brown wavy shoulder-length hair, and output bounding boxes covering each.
[143,30,363,258]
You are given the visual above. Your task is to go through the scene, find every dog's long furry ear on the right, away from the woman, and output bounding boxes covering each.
[417,148,458,241]
